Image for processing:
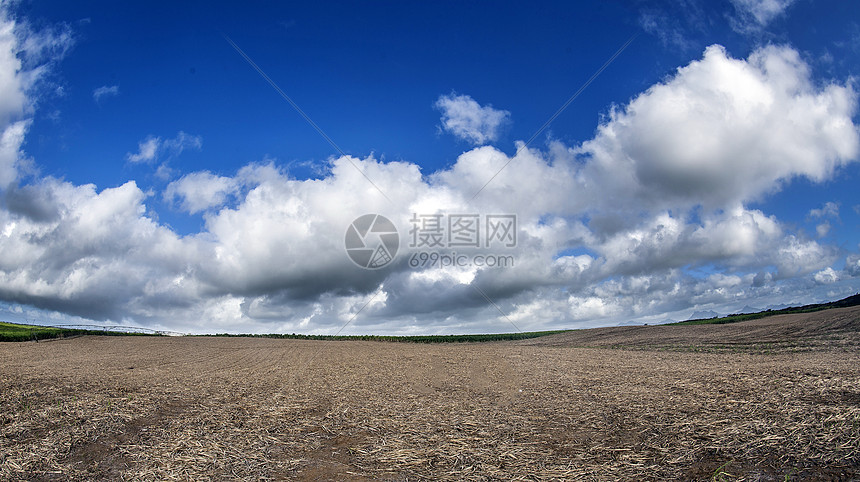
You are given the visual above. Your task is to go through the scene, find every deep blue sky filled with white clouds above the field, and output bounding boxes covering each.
[0,0,860,333]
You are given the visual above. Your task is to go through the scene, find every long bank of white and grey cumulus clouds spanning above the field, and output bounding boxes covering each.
[0,33,858,333]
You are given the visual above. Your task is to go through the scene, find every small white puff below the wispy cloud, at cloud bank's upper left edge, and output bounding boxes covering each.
[164,171,238,214]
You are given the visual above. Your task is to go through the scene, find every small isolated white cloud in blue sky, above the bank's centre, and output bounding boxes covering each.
[435,94,511,145]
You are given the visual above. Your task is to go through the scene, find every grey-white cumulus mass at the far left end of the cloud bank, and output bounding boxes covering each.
[0,179,202,320]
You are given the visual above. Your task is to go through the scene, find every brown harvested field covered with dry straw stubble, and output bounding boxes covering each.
[0,309,860,481]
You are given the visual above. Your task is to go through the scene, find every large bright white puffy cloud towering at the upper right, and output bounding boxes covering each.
[577,45,860,208]
